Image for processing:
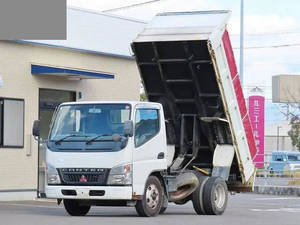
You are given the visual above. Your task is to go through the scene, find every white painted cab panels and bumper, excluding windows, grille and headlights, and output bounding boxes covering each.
[46,101,167,200]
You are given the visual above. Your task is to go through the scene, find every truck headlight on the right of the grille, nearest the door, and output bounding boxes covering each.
[107,164,132,185]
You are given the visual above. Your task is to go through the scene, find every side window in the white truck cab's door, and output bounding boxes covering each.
[134,109,159,147]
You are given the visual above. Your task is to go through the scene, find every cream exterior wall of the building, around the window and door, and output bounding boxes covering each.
[0,41,140,198]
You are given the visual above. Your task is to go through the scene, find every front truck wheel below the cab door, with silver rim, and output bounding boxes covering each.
[135,176,164,217]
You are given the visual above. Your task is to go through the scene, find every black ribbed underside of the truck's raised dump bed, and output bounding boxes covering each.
[133,41,239,172]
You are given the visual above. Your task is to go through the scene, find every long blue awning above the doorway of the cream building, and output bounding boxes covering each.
[31,65,115,79]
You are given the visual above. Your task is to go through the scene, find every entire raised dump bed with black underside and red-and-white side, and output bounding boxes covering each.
[132,11,256,191]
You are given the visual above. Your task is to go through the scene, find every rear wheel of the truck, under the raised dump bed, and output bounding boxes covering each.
[203,177,228,215]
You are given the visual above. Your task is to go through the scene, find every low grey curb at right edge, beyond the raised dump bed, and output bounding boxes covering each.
[253,185,300,197]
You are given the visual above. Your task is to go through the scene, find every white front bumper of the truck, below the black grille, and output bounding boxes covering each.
[45,185,132,200]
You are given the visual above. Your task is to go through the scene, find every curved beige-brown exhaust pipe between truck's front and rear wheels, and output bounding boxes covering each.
[169,172,199,202]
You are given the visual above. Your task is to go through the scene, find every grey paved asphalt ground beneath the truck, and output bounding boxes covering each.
[0,194,300,225]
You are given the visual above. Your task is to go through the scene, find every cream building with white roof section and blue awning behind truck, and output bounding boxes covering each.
[0,8,145,200]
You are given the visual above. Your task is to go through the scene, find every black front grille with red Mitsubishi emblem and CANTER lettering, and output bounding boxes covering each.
[58,168,109,185]
